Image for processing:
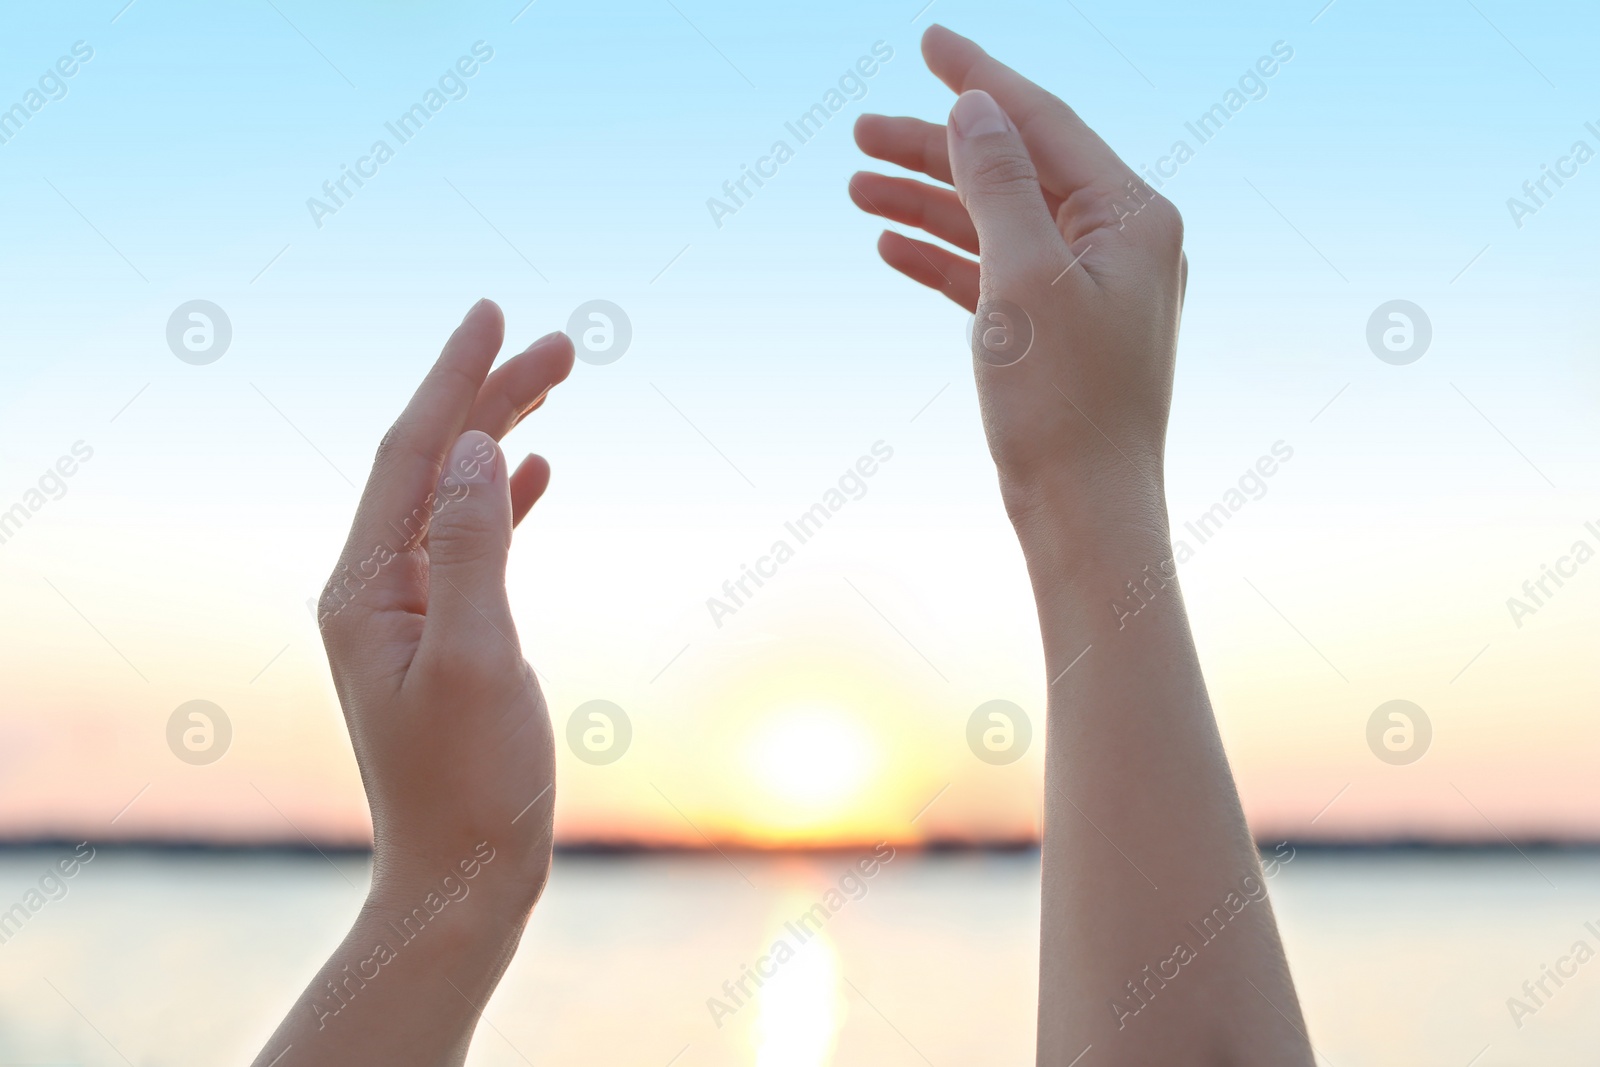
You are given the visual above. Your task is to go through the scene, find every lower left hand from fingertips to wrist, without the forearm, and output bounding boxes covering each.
[318,301,573,907]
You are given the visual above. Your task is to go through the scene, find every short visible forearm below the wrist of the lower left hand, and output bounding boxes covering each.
[254,848,526,1067]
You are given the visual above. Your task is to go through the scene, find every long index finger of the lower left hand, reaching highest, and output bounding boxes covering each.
[330,301,506,611]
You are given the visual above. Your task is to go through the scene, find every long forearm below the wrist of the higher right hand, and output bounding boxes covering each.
[1013,474,1310,1067]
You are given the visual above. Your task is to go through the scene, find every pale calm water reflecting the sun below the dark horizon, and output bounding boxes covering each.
[0,848,1600,1067]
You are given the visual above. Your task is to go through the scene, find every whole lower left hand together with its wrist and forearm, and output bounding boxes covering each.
[256,301,573,1067]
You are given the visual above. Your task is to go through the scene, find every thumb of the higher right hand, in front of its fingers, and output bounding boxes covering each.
[947,90,1066,287]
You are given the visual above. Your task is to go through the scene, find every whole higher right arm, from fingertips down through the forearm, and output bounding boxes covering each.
[850,27,1312,1067]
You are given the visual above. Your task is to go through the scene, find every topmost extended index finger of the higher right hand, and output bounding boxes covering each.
[922,26,1133,197]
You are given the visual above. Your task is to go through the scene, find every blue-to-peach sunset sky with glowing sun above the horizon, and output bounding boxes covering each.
[0,0,1600,846]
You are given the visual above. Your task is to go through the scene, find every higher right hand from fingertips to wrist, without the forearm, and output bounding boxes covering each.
[850,26,1187,517]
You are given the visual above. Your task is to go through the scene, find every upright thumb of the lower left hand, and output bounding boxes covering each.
[427,430,514,645]
